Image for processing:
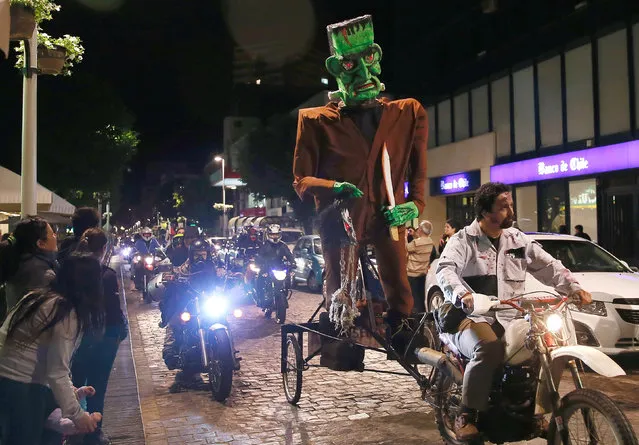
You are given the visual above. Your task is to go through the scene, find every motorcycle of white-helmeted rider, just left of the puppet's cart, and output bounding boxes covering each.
[249,256,292,324]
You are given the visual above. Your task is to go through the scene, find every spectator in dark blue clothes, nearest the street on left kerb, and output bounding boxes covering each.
[71,227,128,445]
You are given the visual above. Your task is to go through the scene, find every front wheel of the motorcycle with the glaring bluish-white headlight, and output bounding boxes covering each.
[208,329,234,402]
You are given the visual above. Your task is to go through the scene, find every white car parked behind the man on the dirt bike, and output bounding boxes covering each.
[426,233,639,355]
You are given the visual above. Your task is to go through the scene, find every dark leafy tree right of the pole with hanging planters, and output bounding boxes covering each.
[38,76,139,212]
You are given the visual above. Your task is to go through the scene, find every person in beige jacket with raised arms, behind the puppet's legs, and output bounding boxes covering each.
[406,221,435,313]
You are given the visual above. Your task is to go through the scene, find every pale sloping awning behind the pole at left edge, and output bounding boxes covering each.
[0,166,75,216]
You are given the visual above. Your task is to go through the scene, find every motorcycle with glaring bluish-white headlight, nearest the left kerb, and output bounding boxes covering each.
[162,273,243,402]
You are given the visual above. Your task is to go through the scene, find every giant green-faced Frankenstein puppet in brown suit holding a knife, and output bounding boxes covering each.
[293,15,428,358]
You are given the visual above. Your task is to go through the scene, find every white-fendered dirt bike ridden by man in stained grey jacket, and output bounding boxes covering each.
[415,292,637,445]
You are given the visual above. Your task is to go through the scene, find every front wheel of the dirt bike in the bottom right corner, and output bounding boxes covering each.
[548,389,637,445]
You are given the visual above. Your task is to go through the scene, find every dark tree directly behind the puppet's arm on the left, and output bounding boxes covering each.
[239,114,315,233]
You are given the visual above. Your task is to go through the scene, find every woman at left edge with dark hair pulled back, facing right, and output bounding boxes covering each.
[1,216,58,311]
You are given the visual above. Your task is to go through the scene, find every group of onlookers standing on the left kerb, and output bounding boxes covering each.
[0,207,128,445]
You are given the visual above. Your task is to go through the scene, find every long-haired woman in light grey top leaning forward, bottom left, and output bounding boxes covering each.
[0,254,103,445]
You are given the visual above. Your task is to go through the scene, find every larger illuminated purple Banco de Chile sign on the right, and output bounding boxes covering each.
[490,141,639,184]
